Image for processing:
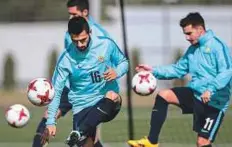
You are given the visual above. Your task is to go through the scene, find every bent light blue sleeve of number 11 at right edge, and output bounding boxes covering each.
[207,44,232,93]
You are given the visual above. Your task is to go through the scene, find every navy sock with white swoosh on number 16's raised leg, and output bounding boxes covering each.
[79,98,116,134]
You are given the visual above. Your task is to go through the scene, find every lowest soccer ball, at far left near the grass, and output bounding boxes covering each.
[5,104,30,128]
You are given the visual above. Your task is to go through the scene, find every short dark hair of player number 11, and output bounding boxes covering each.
[180,12,205,29]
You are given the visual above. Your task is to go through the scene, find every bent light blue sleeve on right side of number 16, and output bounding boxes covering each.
[111,41,129,78]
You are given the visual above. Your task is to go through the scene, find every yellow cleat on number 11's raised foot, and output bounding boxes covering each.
[127,137,158,147]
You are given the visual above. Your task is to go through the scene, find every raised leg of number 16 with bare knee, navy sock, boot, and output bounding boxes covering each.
[66,91,121,147]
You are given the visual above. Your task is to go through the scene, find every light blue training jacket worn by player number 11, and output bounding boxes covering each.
[153,30,232,111]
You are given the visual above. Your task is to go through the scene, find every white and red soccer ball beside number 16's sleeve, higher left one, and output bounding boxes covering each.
[27,78,55,106]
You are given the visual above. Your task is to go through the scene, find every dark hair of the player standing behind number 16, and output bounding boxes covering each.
[67,0,89,11]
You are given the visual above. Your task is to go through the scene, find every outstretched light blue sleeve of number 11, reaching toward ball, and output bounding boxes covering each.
[152,48,189,79]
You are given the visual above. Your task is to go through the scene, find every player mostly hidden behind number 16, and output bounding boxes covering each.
[32,0,109,147]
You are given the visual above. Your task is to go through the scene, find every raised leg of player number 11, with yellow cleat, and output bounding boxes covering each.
[128,87,193,147]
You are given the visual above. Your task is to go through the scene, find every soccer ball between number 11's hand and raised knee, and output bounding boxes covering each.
[132,71,157,96]
